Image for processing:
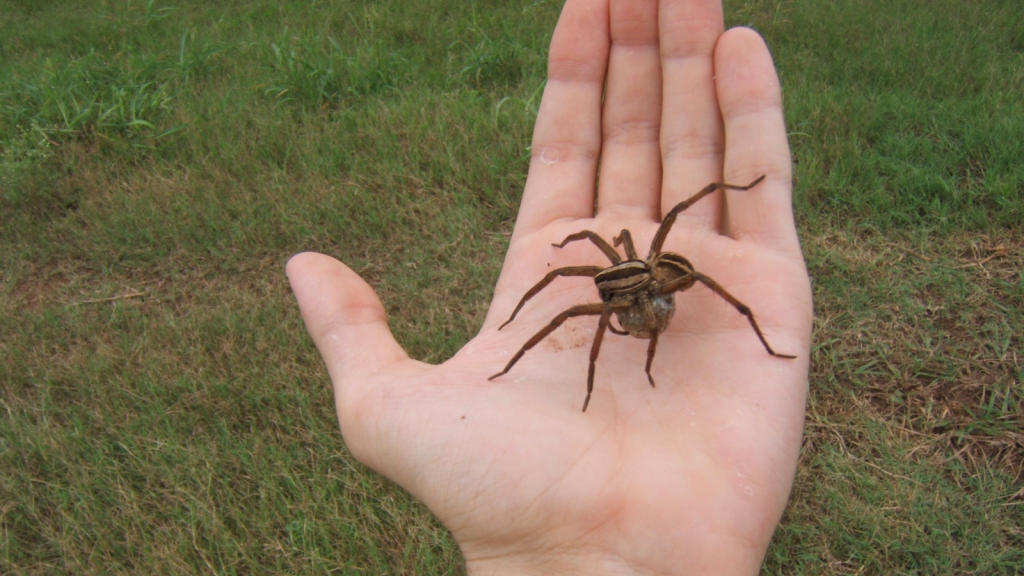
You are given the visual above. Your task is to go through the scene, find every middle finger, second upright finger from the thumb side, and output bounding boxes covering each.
[597,0,662,219]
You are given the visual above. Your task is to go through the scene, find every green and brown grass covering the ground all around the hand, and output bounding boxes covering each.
[0,0,1024,575]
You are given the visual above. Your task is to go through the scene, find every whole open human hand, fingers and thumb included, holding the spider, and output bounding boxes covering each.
[288,0,811,574]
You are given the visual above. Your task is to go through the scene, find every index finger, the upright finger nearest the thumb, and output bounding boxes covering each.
[514,0,608,236]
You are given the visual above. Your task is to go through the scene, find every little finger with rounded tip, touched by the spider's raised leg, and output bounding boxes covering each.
[715,28,800,251]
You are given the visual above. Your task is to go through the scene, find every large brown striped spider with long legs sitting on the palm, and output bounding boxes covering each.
[487,175,797,412]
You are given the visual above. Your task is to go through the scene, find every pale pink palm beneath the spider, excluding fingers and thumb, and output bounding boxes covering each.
[407,212,806,567]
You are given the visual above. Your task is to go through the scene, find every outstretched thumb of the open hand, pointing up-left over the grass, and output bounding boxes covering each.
[287,252,409,385]
